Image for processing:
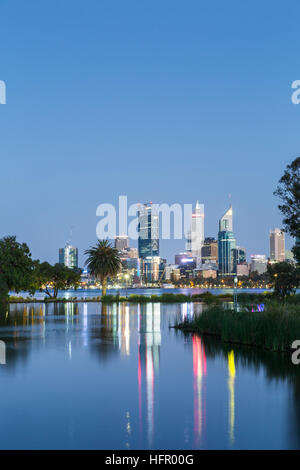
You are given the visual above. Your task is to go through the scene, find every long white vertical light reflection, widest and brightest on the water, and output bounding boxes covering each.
[138,303,161,447]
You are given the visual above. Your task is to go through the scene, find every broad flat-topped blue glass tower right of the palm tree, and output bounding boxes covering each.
[138,203,159,259]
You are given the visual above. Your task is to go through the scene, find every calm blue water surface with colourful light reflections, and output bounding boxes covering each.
[0,303,300,449]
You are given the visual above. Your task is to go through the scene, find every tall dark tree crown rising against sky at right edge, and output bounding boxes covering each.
[274,157,300,263]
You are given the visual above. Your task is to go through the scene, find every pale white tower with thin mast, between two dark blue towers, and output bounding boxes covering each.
[187,201,204,266]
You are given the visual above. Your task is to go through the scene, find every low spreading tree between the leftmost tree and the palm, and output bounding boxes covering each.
[35,262,81,299]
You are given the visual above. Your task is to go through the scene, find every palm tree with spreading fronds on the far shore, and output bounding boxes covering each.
[84,240,122,296]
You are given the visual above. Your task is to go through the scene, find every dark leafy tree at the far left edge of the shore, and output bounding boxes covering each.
[0,236,34,300]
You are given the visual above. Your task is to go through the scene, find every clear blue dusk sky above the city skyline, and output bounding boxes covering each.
[0,0,300,262]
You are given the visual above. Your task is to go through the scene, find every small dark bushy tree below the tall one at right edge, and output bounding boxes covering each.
[268,261,299,299]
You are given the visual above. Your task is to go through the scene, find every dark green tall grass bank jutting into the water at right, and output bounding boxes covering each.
[176,302,300,351]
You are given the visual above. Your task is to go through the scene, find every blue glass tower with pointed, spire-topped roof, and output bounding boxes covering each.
[218,204,236,276]
